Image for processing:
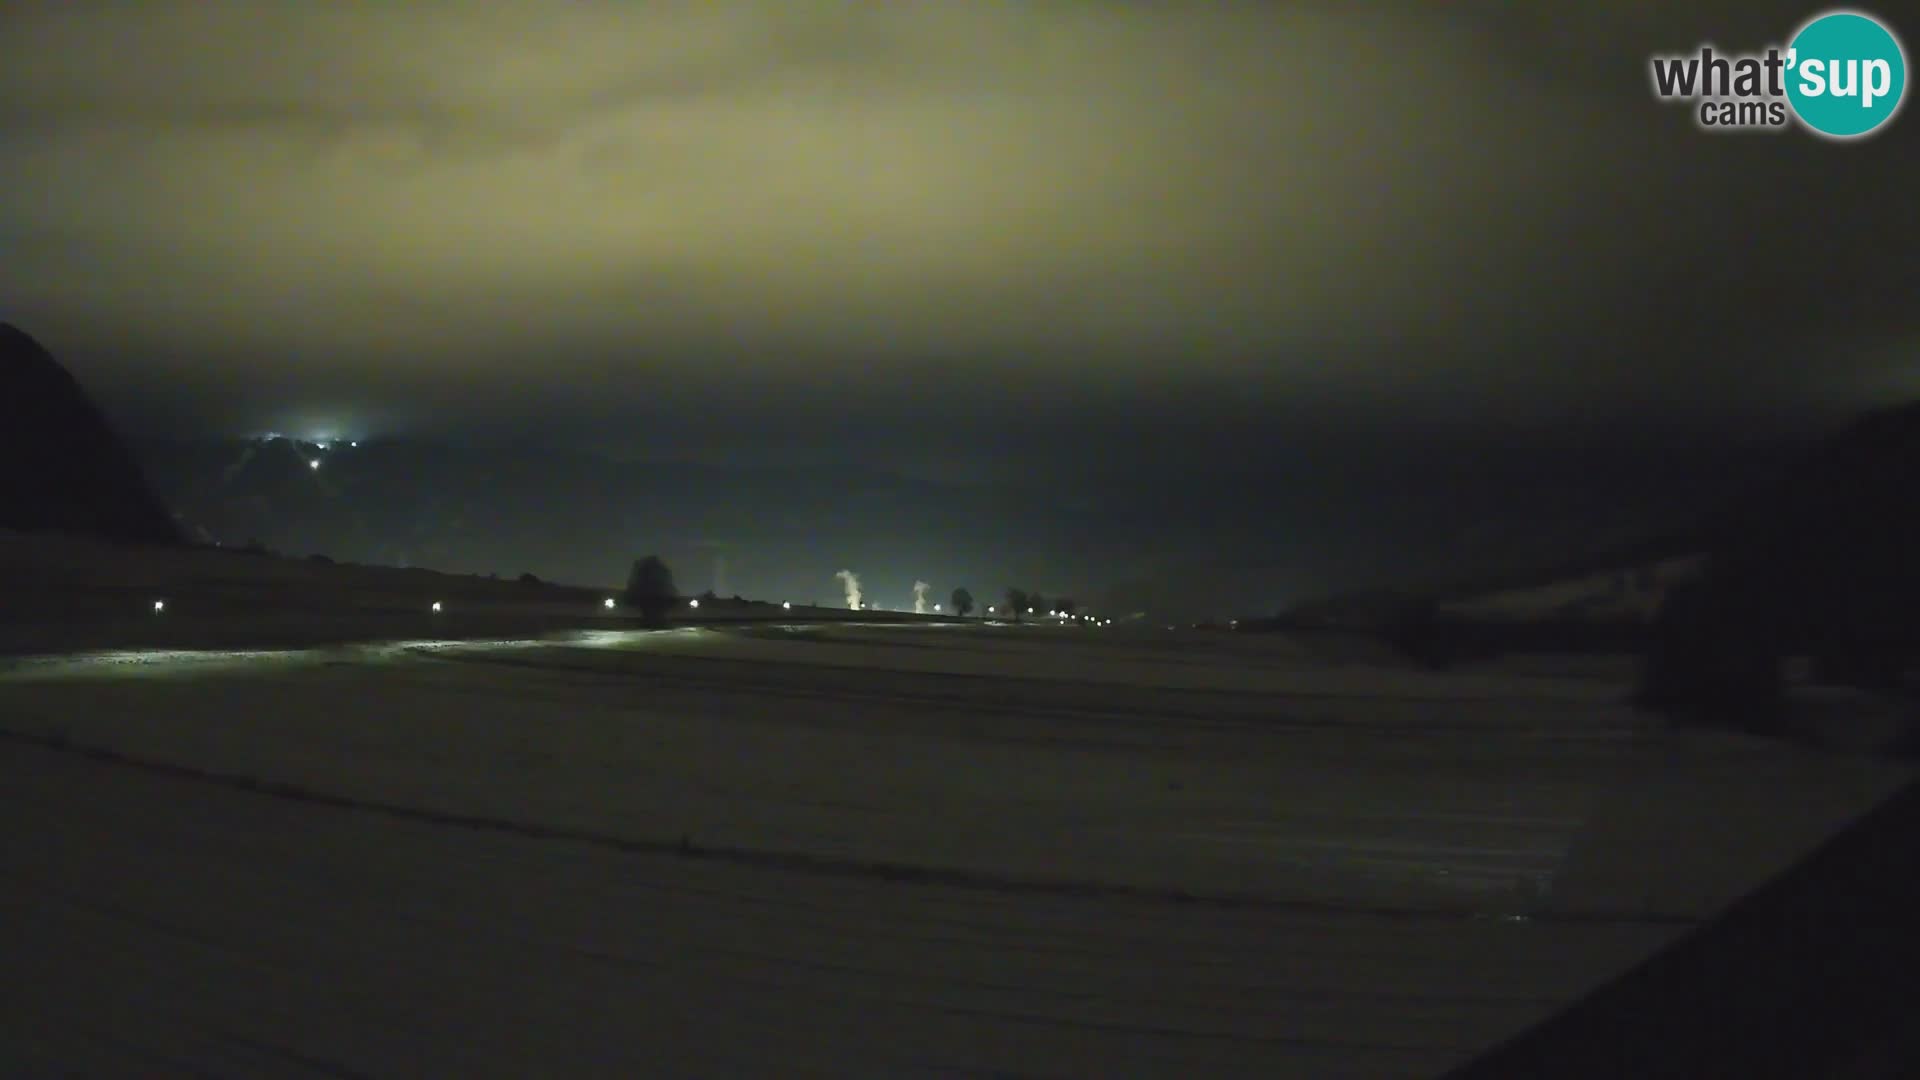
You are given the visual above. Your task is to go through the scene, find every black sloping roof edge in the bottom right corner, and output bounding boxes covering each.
[1448,784,1920,1080]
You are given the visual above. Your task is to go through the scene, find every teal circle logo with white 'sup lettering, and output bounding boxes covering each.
[1788,12,1907,138]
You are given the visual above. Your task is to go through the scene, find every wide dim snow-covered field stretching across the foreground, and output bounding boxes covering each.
[0,625,1908,1076]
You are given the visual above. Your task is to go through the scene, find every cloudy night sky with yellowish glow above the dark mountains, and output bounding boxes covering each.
[0,0,1920,614]
